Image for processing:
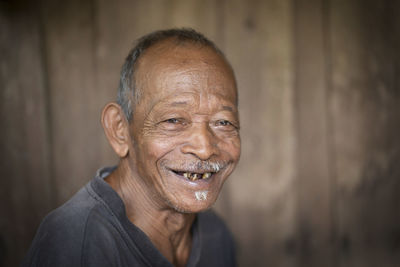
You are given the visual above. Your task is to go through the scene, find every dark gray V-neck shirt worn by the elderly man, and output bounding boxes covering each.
[22,168,235,267]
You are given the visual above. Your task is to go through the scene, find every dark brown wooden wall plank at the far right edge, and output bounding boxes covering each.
[330,0,400,267]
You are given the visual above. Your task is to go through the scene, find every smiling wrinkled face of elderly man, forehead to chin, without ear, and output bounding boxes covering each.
[129,41,240,212]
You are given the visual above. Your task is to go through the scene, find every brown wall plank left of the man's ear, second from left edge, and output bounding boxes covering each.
[41,1,101,205]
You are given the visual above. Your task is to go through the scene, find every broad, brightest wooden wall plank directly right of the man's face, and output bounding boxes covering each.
[223,0,297,266]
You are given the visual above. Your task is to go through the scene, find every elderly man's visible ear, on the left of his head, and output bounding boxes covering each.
[101,102,130,158]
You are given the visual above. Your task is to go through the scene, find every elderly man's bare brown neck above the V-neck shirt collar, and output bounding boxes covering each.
[105,162,195,266]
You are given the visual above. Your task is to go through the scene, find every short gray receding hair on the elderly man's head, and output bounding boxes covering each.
[117,28,225,122]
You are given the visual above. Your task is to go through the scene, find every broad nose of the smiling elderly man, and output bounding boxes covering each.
[181,123,218,160]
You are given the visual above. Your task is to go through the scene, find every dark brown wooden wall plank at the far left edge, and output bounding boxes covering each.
[0,1,52,266]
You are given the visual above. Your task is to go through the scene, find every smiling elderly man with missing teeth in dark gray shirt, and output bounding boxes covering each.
[23,29,240,266]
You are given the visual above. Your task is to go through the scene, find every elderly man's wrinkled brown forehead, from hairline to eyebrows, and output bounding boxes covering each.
[135,41,237,104]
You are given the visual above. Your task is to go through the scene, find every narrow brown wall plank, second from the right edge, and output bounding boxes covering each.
[294,0,335,267]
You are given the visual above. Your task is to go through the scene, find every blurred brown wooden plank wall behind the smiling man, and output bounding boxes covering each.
[0,0,400,267]
